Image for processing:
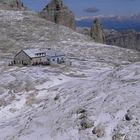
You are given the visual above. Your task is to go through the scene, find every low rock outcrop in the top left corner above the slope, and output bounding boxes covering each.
[0,0,26,10]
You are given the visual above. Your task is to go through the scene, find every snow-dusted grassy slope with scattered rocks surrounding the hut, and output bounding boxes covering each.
[0,11,140,140]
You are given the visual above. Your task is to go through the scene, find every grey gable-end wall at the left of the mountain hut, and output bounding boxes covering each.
[14,51,31,64]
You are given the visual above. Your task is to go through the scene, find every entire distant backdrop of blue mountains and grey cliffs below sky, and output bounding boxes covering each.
[77,15,140,51]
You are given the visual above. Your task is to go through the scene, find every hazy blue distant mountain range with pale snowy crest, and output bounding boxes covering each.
[76,15,140,31]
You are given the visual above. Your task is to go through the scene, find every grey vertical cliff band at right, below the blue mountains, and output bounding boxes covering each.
[106,30,140,51]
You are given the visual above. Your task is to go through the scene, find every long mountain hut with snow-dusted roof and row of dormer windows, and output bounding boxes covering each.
[13,49,66,65]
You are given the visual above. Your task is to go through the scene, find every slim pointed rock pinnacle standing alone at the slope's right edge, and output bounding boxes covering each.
[90,18,106,43]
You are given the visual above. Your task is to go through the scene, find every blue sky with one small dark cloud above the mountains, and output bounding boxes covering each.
[22,0,140,17]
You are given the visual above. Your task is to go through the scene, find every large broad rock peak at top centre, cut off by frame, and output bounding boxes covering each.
[40,0,76,29]
